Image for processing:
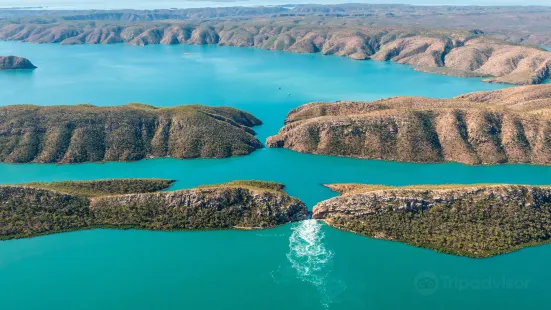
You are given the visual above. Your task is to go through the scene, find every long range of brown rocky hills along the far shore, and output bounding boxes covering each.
[0,6,551,85]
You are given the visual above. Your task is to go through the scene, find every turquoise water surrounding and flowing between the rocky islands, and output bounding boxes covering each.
[0,42,551,309]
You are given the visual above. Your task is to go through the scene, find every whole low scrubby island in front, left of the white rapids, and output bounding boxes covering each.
[0,179,308,239]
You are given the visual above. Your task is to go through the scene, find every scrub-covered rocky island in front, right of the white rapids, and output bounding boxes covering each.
[312,185,551,257]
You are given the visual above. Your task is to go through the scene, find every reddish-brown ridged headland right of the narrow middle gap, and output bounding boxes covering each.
[267,85,551,165]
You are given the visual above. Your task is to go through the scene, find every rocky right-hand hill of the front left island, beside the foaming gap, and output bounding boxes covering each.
[90,187,307,230]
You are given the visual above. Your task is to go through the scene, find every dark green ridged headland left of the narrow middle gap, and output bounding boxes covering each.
[0,104,262,163]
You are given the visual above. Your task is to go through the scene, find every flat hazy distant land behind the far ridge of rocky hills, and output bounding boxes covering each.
[4,3,551,46]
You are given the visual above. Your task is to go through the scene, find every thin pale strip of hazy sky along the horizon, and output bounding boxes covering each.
[0,0,551,9]
